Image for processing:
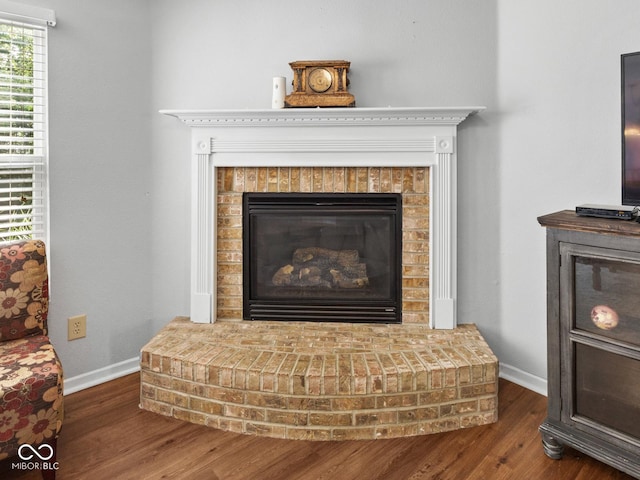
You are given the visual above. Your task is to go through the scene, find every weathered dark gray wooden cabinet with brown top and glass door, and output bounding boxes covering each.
[538,210,640,478]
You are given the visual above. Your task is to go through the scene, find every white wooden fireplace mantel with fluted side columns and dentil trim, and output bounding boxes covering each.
[161,107,484,328]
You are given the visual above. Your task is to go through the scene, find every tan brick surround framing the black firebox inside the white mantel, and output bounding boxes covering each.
[217,167,430,325]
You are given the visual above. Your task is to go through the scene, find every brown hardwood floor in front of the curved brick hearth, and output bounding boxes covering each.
[0,375,631,480]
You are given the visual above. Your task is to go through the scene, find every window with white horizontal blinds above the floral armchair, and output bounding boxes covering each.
[0,2,54,243]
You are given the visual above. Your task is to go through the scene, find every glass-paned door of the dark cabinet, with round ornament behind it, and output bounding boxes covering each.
[560,244,640,438]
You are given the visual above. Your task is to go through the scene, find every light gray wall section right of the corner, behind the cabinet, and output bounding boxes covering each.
[496,0,640,390]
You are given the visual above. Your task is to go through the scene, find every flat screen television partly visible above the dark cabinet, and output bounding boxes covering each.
[621,52,640,206]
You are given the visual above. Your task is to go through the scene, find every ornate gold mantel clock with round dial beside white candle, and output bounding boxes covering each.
[284,60,356,107]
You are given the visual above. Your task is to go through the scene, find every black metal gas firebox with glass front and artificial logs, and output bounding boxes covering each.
[243,193,402,323]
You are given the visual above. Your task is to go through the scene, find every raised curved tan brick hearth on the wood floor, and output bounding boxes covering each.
[141,317,498,440]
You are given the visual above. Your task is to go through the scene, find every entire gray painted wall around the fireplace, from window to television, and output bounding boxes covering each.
[17,0,640,391]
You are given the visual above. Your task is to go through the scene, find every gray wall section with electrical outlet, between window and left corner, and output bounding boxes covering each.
[23,0,154,379]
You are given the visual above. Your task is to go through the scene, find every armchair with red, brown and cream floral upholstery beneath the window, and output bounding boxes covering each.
[0,240,63,478]
